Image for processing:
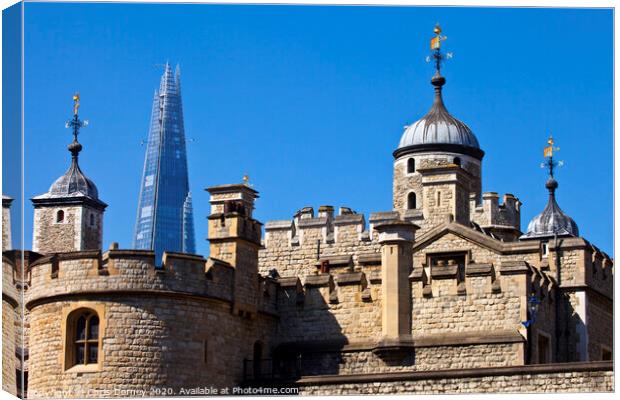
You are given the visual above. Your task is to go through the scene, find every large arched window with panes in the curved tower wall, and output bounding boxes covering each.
[67,309,99,367]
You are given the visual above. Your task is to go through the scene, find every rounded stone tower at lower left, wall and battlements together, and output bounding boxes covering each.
[26,250,277,397]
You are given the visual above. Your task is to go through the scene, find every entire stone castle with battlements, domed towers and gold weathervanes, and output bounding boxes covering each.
[2,25,614,398]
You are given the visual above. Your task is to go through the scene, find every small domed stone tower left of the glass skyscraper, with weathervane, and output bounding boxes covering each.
[31,93,107,254]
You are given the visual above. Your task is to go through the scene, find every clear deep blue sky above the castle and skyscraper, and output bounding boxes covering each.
[5,3,613,254]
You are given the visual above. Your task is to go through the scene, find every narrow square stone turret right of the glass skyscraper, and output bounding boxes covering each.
[206,182,261,317]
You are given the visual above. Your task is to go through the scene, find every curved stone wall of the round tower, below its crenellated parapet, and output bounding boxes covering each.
[29,294,275,397]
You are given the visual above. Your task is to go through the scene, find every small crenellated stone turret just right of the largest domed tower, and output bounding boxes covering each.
[469,192,521,241]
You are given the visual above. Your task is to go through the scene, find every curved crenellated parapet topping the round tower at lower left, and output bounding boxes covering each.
[25,249,276,312]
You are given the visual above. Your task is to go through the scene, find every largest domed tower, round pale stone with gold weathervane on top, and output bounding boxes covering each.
[393,26,484,227]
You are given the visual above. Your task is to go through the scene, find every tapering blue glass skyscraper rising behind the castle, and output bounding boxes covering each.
[133,63,196,262]
